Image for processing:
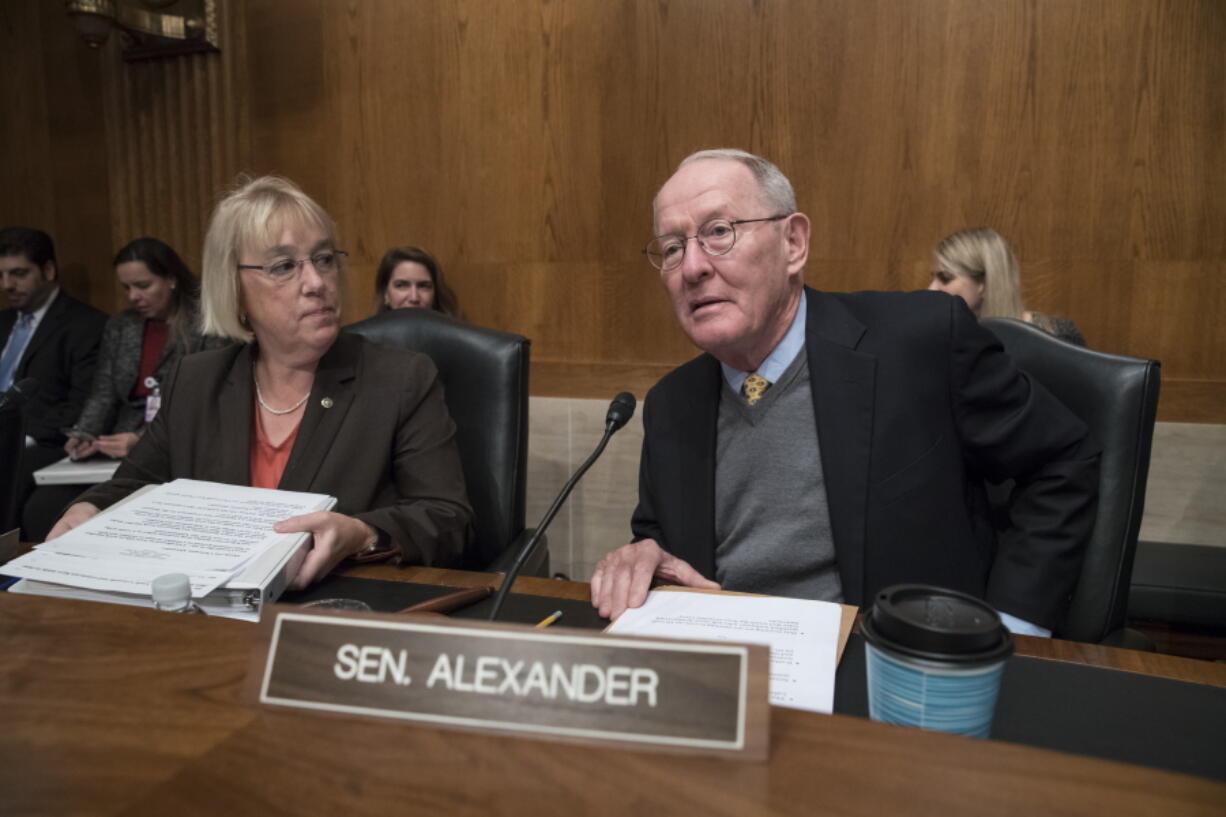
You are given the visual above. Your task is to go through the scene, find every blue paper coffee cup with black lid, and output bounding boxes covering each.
[861,584,1013,737]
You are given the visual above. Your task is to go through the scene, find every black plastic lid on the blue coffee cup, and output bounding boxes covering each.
[859,584,1013,664]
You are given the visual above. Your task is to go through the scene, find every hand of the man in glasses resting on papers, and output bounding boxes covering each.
[591,539,720,618]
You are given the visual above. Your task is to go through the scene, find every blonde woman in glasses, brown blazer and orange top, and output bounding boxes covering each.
[50,177,472,588]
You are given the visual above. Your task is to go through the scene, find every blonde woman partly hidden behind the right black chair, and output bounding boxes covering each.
[928,227,1085,346]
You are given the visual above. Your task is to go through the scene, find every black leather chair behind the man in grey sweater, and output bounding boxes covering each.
[983,318,1160,649]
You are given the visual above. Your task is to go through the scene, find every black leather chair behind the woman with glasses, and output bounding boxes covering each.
[345,309,549,575]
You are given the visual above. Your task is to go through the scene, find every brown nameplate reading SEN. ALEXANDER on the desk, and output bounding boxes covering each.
[248,607,770,759]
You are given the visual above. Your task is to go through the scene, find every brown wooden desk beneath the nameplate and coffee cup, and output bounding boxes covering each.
[0,567,1226,817]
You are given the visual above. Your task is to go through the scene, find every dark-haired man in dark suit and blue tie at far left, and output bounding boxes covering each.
[0,227,107,522]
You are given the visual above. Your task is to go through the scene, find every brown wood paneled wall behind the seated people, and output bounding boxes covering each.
[0,0,1226,422]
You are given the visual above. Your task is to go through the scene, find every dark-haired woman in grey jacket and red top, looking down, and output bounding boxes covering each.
[22,238,221,542]
